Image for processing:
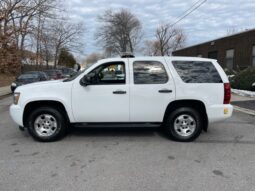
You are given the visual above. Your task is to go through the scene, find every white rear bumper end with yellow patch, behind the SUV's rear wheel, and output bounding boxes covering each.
[207,104,233,123]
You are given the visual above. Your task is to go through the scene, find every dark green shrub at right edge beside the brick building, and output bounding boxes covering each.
[230,68,255,91]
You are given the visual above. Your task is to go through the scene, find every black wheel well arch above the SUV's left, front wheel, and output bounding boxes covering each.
[23,100,69,127]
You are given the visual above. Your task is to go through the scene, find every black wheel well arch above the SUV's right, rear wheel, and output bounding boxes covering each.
[163,100,208,131]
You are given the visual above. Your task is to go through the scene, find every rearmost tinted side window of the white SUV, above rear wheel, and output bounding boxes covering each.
[173,61,222,83]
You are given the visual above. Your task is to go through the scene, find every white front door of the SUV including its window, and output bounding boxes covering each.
[72,61,129,122]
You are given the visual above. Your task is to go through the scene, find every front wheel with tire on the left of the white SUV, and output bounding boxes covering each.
[27,107,68,142]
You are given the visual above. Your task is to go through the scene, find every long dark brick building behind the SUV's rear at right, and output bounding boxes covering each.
[173,29,255,70]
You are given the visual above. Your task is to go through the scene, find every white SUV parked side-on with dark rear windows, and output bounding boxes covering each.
[10,57,233,141]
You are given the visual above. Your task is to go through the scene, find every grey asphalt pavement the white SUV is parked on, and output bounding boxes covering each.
[0,97,255,191]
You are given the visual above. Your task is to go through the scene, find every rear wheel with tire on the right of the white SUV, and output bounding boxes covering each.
[165,107,203,142]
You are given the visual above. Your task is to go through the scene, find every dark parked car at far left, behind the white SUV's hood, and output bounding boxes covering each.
[11,71,49,92]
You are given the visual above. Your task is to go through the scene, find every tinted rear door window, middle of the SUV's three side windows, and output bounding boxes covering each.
[133,61,168,84]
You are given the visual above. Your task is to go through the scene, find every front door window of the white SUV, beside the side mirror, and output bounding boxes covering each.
[88,62,126,84]
